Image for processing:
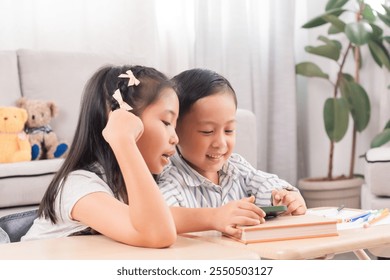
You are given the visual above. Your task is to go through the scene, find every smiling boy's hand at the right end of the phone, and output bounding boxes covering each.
[272,189,307,215]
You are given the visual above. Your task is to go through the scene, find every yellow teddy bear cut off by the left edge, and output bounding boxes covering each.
[0,107,31,163]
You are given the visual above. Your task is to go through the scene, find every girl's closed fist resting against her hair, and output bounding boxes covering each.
[102,109,144,145]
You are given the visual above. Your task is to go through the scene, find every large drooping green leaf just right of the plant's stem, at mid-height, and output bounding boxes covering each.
[340,78,371,132]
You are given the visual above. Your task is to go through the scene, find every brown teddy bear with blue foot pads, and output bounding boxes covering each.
[16,97,68,160]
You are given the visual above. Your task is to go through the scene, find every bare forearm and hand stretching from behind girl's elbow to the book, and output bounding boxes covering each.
[171,197,265,237]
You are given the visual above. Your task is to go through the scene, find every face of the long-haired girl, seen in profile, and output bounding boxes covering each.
[137,88,179,174]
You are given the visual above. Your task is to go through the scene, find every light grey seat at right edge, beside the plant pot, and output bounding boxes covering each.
[364,147,390,197]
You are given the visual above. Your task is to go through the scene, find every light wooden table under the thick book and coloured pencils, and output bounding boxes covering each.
[183,225,390,260]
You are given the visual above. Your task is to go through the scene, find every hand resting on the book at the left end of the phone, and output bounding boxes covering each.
[215,196,265,238]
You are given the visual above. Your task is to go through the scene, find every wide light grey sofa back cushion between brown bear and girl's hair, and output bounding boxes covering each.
[17,50,128,144]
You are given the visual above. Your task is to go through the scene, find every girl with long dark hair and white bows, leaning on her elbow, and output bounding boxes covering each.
[22,66,179,248]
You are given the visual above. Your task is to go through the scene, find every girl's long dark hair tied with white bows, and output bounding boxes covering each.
[39,65,173,224]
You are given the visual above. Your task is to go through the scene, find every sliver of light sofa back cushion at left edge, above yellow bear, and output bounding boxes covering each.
[0,51,21,106]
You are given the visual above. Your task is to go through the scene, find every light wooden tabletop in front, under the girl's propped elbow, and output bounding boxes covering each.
[0,235,259,260]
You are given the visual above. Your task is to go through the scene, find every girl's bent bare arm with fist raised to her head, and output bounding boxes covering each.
[72,109,176,248]
